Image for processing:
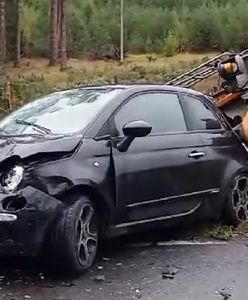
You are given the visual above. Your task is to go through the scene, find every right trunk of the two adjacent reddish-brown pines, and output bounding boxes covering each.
[60,0,67,71]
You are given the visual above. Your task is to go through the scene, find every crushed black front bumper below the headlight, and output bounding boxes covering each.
[0,186,64,256]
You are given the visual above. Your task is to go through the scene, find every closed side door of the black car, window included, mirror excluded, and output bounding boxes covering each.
[110,91,211,224]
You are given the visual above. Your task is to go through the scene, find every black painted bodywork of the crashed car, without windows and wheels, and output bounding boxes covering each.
[0,86,248,255]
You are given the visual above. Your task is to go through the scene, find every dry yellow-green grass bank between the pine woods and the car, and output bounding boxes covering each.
[0,53,221,106]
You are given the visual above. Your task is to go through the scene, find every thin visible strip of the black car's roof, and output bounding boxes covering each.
[79,84,204,95]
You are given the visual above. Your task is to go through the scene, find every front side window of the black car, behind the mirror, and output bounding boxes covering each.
[114,93,187,136]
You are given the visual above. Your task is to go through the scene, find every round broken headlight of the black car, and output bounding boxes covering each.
[1,165,24,193]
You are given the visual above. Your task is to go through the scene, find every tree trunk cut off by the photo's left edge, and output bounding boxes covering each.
[0,0,6,75]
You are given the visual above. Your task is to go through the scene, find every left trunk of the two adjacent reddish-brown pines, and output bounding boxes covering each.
[49,0,61,66]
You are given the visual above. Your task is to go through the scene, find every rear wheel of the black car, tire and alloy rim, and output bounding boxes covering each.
[224,174,248,226]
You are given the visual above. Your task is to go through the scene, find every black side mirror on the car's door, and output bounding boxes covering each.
[117,120,152,152]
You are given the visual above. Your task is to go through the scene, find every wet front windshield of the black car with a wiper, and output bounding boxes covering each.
[0,88,119,135]
